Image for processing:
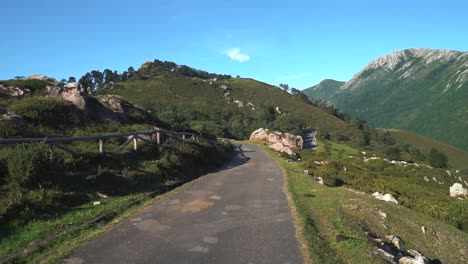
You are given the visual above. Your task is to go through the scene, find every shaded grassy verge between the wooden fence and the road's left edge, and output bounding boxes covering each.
[0,141,231,263]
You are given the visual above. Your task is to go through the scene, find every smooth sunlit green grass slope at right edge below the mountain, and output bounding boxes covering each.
[383,129,468,169]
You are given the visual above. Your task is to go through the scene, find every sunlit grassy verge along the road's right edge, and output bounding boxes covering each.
[264,144,468,263]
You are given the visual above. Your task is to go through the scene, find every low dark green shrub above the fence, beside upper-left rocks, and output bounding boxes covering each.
[12,97,80,127]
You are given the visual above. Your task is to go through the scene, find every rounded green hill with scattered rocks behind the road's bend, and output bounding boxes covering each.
[99,61,356,138]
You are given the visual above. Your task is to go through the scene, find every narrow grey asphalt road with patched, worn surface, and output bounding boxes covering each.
[63,145,303,264]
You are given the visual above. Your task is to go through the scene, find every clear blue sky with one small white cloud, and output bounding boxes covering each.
[0,0,468,89]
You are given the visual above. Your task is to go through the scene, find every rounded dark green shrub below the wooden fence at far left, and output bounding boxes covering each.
[5,143,64,198]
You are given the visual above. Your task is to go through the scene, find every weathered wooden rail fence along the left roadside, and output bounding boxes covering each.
[0,128,203,155]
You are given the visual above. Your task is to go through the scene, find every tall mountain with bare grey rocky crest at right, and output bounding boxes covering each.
[306,49,468,150]
